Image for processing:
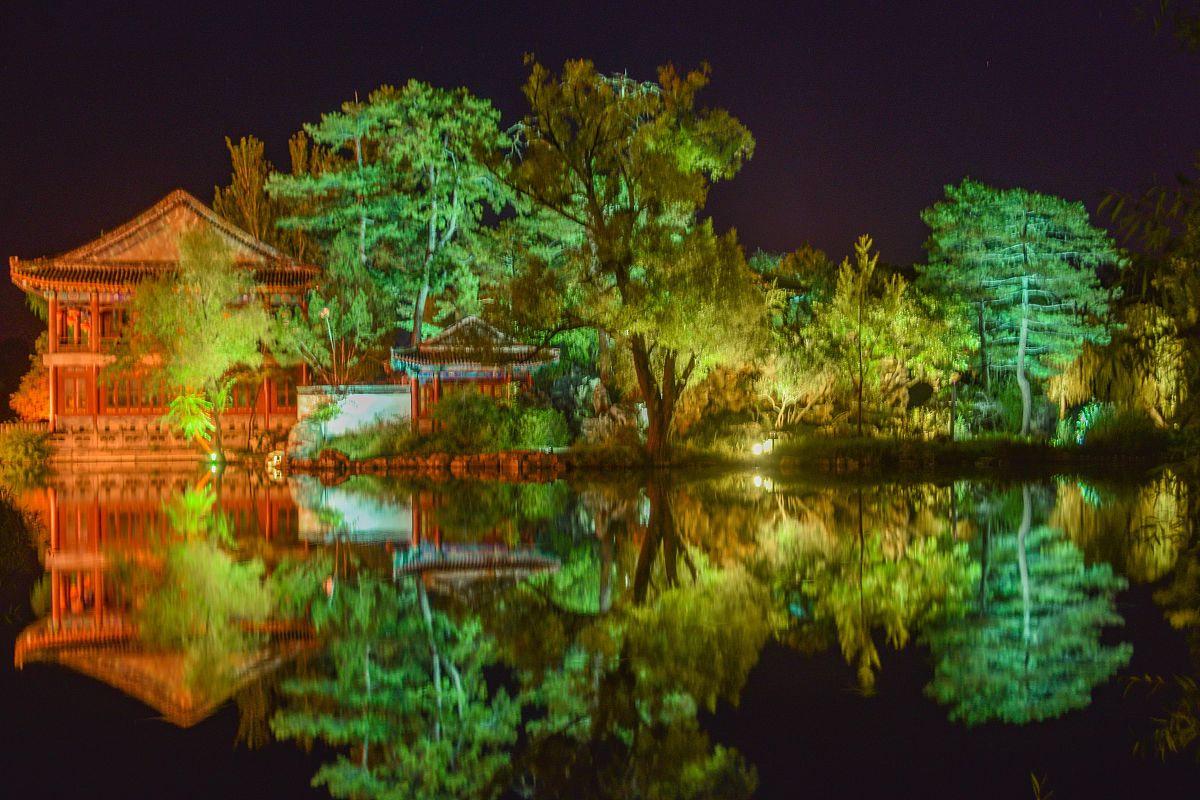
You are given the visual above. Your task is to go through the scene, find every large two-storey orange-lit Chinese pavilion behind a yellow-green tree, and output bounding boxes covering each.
[8,190,319,432]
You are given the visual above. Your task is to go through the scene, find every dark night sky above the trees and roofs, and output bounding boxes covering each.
[0,0,1200,339]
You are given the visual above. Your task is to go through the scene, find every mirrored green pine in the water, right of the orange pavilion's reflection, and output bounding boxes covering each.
[271,573,520,798]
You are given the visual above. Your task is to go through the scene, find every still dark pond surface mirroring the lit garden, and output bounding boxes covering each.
[0,471,1200,798]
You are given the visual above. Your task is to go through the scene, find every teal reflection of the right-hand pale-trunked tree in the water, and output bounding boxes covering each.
[925,486,1132,724]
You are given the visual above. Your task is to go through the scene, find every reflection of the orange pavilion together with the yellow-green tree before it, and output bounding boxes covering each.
[14,474,311,727]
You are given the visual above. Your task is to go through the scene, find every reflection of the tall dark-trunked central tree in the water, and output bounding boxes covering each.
[486,476,772,798]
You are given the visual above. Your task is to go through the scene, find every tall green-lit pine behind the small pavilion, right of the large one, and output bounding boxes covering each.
[266,80,508,343]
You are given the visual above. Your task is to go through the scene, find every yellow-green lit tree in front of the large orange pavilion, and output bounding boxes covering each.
[108,229,269,461]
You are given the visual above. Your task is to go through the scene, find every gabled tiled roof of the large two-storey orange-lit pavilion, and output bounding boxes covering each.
[8,190,320,294]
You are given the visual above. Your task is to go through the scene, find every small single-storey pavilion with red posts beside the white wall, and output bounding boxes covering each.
[391,317,558,433]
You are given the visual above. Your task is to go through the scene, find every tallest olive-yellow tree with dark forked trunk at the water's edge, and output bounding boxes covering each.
[506,61,766,461]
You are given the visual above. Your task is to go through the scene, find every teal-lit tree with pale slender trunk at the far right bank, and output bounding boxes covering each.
[922,179,1121,435]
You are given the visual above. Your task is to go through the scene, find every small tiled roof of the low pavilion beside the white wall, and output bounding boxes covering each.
[391,315,558,372]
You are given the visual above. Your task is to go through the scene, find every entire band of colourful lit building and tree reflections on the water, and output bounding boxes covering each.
[4,473,1200,798]
